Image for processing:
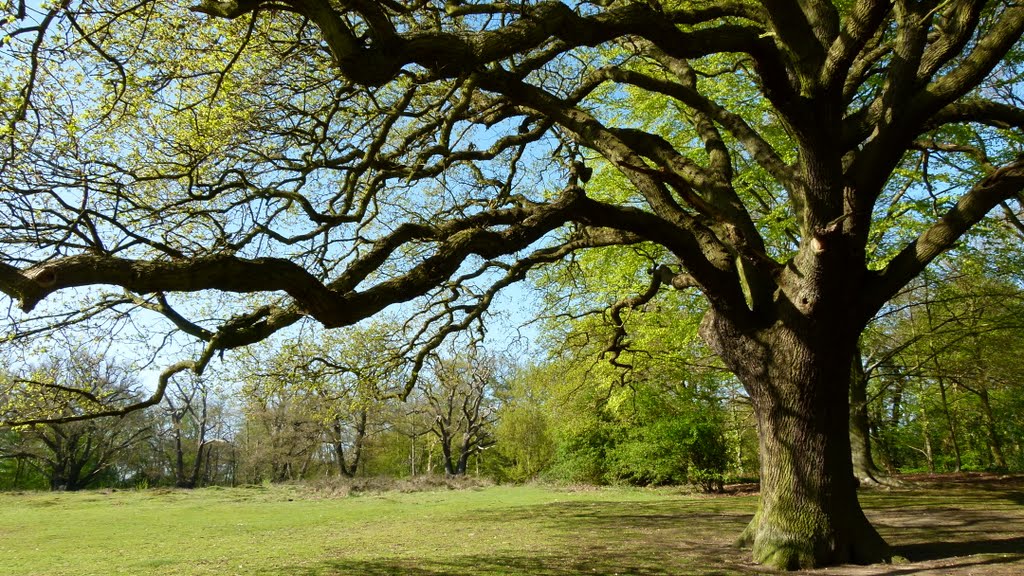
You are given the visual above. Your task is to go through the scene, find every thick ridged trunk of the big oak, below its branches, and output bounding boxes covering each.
[701,313,890,570]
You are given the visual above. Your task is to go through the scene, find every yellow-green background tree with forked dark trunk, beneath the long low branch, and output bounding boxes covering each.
[233,322,404,478]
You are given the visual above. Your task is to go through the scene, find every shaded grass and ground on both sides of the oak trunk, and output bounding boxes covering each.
[259,477,1024,576]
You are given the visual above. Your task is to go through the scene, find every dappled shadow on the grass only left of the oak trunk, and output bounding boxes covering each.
[259,500,764,576]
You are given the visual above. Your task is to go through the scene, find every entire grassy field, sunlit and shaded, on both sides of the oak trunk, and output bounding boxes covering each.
[0,479,1024,576]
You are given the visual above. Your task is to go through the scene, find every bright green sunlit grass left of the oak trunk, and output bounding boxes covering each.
[0,487,754,576]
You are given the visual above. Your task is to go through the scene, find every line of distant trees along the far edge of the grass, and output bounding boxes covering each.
[0,259,1024,490]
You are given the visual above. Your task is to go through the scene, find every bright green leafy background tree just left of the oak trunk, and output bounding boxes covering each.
[537,239,757,490]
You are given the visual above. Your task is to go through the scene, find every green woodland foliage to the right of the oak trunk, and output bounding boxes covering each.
[862,249,1024,472]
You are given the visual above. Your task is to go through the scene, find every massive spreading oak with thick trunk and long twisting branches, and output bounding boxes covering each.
[0,0,1024,568]
